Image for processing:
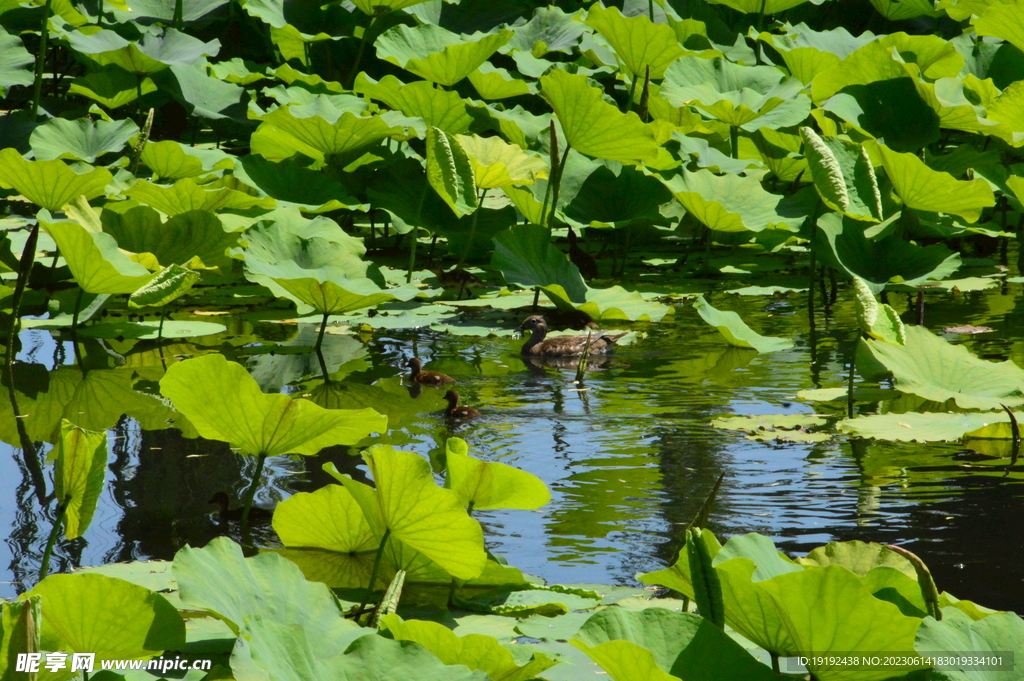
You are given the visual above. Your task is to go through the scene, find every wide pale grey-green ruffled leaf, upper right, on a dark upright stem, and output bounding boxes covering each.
[660,56,811,131]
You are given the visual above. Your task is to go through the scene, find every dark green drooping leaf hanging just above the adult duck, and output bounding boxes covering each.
[490,224,587,303]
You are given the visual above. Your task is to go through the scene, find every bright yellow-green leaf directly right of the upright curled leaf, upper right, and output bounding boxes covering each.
[879,144,995,222]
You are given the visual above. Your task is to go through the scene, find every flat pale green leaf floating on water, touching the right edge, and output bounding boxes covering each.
[837,412,1024,442]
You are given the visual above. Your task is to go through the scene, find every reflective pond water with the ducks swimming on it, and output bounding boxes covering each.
[0,284,1024,611]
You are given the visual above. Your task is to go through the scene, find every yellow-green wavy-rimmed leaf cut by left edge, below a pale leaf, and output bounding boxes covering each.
[0,147,113,211]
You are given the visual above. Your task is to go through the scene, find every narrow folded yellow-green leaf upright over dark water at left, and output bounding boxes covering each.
[53,420,106,539]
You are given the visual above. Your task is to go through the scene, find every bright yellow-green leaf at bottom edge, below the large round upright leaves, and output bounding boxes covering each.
[381,614,557,681]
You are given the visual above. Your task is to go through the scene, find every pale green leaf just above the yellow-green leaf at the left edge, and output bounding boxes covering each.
[31,118,138,163]
